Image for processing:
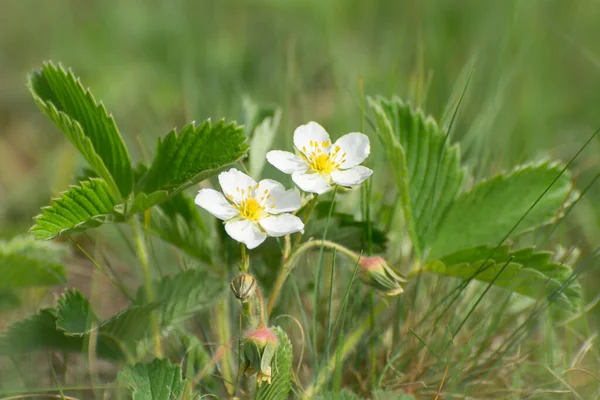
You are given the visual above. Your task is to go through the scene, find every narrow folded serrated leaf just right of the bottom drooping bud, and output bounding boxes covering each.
[254,326,293,400]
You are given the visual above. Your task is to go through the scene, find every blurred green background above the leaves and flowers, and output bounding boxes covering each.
[0,0,600,250]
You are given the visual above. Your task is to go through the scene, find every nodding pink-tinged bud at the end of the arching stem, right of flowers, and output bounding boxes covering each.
[359,256,407,296]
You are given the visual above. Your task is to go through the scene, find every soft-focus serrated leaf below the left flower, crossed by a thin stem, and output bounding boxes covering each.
[136,269,226,328]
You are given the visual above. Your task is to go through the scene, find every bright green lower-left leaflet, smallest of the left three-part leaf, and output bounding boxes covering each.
[31,179,119,240]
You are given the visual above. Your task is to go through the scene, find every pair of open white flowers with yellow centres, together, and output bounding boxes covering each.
[196,122,373,249]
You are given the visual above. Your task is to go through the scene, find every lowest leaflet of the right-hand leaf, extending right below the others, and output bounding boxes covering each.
[425,246,581,310]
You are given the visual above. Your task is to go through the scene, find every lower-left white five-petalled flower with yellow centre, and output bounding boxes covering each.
[196,168,304,249]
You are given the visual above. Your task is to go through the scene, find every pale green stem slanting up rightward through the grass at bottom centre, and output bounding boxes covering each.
[303,300,387,399]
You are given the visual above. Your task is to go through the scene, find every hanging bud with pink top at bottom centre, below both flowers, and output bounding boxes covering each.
[242,328,278,386]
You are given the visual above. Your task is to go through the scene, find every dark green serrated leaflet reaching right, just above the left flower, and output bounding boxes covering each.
[138,120,248,196]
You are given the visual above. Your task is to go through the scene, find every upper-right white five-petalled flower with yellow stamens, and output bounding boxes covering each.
[267,122,373,194]
